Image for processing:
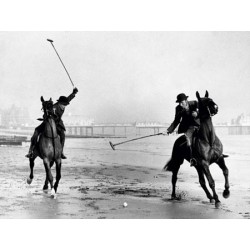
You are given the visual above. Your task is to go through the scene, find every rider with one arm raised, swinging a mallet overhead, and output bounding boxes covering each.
[25,88,78,159]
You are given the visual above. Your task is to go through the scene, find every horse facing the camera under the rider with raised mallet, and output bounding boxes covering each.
[27,97,62,198]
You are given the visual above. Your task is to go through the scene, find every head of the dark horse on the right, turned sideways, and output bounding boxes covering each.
[196,90,218,118]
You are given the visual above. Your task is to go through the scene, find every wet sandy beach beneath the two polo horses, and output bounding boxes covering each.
[0,136,250,219]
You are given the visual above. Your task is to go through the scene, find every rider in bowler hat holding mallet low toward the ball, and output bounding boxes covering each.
[166,93,200,166]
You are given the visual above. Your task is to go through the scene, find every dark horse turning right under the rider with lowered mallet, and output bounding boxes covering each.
[164,91,230,208]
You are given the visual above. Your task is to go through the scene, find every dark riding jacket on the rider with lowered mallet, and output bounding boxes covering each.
[167,101,200,134]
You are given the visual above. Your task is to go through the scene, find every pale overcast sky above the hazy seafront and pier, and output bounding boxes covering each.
[0,31,250,123]
